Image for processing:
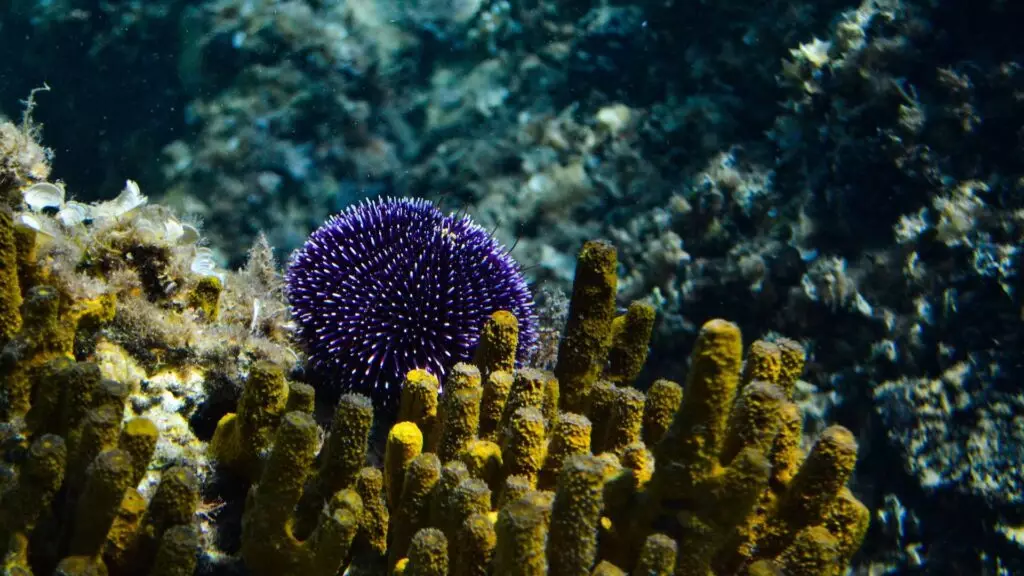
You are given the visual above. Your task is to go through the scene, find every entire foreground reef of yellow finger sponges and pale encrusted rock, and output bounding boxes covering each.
[0,117,868,576]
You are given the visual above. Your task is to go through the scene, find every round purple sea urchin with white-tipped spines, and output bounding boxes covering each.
[287,194,537,406]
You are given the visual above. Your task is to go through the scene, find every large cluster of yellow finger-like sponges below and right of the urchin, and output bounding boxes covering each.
[203,242,869,575]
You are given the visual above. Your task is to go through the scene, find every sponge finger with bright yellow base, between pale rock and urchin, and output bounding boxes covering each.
[210,362,288,481]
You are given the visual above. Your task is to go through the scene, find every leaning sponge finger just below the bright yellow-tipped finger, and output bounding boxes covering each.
[388,452,441,567]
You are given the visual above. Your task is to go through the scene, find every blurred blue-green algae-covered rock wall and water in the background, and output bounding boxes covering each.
[9,0,1024,573]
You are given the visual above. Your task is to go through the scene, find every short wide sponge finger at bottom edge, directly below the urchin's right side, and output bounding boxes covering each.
[494,498,548,576]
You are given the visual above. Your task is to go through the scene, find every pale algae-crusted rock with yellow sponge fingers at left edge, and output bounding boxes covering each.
[0,117,297,575]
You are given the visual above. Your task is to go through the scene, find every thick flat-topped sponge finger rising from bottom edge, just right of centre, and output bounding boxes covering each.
[548,455,604,576]
